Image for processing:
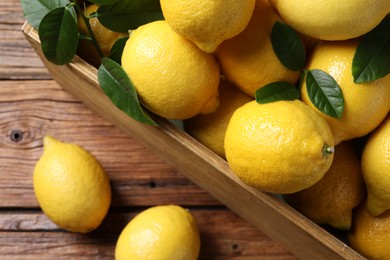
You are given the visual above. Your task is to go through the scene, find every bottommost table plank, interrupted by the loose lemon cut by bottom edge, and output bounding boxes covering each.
[0,208,296,260]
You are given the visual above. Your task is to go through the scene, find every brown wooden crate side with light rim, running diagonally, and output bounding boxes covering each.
[22,23,364,259]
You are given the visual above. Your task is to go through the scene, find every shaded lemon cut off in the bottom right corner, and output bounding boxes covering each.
[348,203,390,260]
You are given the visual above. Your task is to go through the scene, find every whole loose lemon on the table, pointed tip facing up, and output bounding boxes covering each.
[33,136,111,233]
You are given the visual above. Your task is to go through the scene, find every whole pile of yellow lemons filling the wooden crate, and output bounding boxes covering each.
[33,0,390,259]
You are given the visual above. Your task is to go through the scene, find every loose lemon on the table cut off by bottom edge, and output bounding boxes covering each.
[115,205,200,260]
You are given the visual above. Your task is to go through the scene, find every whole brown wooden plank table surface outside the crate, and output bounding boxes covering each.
[0,0,295,259]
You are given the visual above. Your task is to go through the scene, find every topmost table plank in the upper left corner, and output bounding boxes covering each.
[0,0,51,79]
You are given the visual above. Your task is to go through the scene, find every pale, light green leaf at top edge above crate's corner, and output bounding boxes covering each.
[21,0,70,30]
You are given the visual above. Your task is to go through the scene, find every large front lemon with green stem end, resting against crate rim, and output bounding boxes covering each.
[225,100,333,194]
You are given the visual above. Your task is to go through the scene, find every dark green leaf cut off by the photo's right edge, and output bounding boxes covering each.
[352,17,390,83]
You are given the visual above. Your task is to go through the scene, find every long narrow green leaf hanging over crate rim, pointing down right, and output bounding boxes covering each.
[98,58,157,126]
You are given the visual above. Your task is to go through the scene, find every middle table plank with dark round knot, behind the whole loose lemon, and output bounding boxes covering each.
[0,81,220,207]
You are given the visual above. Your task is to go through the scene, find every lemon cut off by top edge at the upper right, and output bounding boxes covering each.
[271,0,390,41]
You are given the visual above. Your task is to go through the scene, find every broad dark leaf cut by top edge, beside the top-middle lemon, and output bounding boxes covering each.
[97,0,164,32]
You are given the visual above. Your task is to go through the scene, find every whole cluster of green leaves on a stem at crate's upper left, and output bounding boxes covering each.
[21,0,163,125]
